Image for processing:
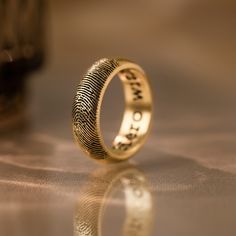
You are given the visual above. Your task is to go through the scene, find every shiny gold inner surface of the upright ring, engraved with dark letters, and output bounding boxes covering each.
[104,69,152,158]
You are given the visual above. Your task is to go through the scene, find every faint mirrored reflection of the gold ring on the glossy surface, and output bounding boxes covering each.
[74,167,152,236]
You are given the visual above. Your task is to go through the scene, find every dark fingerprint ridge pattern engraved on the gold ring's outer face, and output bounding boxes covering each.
[72,58,119,159]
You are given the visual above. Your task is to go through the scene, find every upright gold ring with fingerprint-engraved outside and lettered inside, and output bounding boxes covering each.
[72,58,152,162]
